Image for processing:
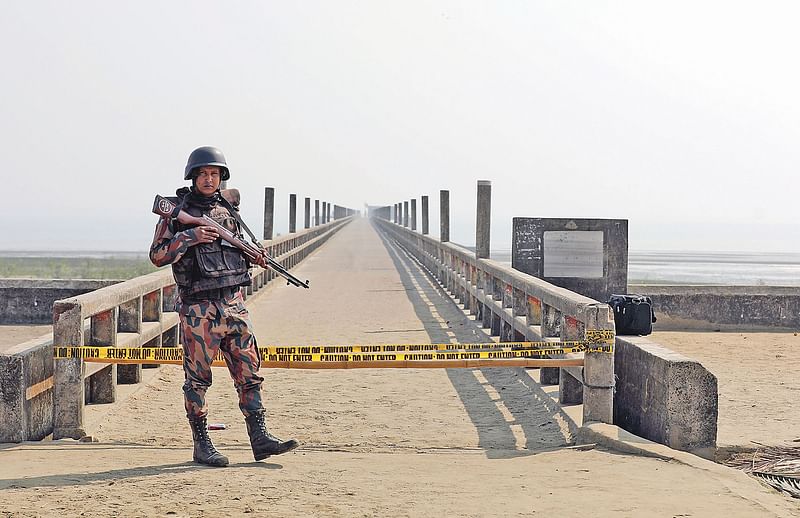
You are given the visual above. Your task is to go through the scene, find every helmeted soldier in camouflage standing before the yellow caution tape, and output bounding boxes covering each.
[150,147,298,472]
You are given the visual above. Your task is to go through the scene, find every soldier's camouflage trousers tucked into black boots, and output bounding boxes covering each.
[178,293,264,419]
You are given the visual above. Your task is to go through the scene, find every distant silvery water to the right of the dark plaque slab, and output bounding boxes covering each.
[492,250,800,286]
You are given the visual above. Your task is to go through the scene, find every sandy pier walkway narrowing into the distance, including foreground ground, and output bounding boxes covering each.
[0,218,800,517]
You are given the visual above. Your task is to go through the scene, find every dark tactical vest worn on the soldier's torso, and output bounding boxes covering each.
[172,191,252,301]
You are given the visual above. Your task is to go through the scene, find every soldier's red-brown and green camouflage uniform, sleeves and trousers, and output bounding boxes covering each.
[150,193,264,419]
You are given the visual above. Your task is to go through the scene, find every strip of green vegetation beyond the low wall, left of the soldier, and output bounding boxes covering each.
[0,257,157,280]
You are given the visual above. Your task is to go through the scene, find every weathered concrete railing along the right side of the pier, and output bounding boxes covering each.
[372,218,614,424]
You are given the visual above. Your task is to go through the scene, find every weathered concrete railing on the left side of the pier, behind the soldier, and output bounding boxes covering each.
[50,217,352,439]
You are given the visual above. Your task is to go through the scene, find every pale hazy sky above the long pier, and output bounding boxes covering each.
[0,0,800,252]
